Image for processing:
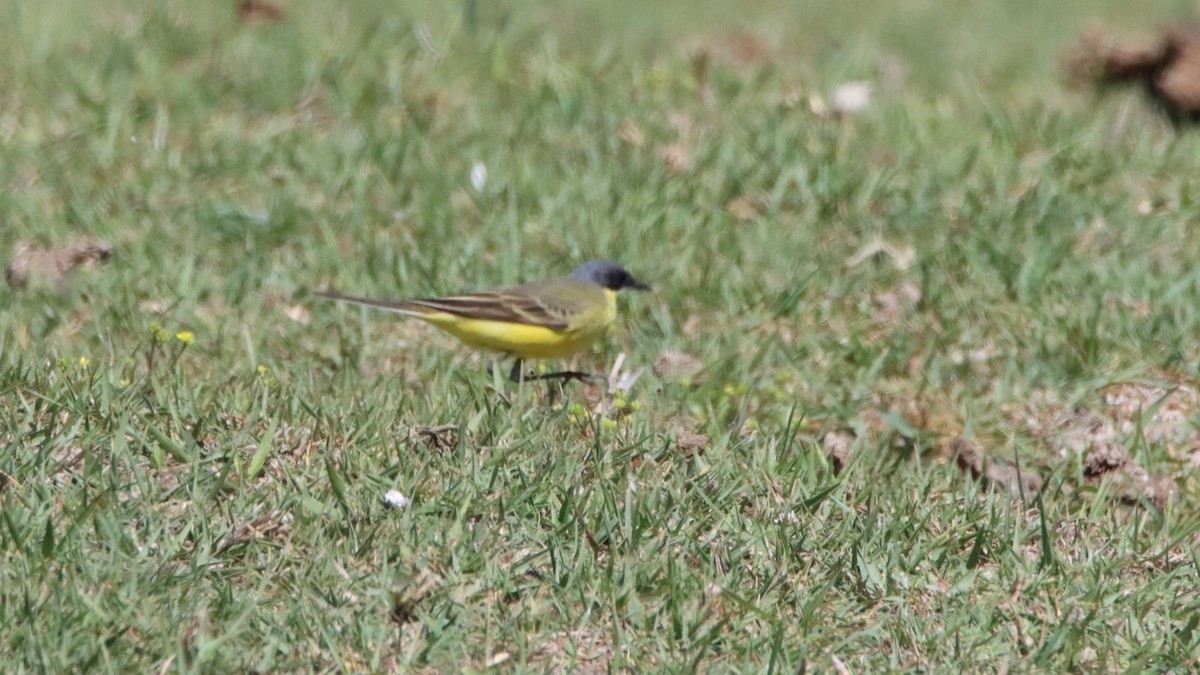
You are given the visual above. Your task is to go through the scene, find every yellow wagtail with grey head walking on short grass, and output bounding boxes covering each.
[316,261,650,382]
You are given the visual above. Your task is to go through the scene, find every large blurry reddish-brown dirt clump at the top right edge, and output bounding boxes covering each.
[1062,25,1200,124]
